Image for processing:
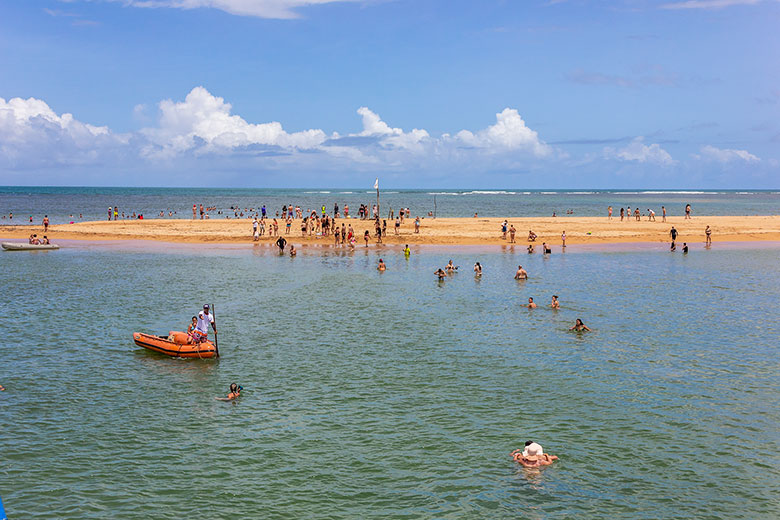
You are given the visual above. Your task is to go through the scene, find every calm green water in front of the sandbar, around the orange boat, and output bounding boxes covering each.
[0,246,780,519]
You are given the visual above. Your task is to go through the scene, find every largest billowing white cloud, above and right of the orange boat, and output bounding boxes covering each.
[141,87,327,157]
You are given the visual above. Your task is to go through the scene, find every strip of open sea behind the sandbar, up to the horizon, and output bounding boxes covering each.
[0,187,780,225]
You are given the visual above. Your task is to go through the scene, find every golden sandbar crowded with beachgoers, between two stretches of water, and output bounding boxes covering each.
[0,215,780,246]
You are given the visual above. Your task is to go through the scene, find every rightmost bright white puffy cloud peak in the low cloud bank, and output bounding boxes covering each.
[448,108,551,157]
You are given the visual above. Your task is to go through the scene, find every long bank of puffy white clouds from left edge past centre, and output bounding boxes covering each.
[0,86,563,169]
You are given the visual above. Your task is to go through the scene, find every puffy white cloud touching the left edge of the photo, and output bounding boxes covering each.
[0,94,128,166]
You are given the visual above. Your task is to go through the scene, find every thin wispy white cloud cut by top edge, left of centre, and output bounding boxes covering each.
[114,0,355,19]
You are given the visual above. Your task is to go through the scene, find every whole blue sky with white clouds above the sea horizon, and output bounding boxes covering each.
[0,0,780,189]
